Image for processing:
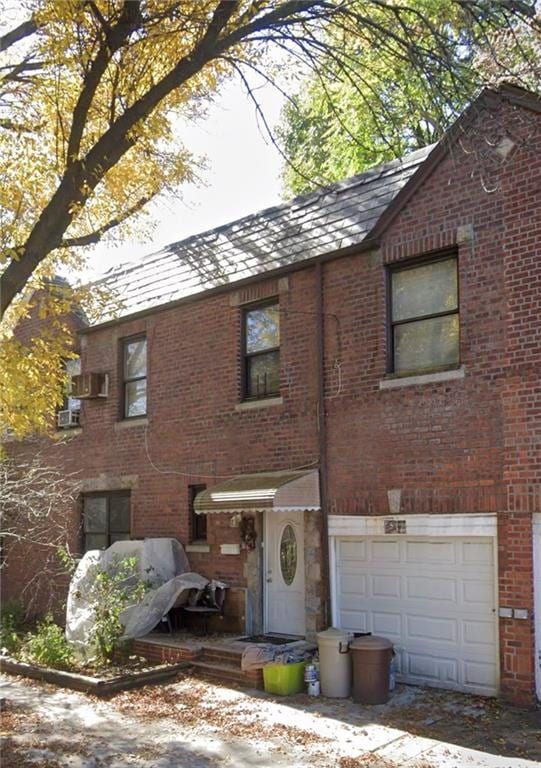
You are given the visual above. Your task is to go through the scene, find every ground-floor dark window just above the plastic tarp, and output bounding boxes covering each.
[83,491,131,552]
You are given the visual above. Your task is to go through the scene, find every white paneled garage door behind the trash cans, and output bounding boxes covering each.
[336,536,499,695]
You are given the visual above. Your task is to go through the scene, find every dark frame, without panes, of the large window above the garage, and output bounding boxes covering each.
[385,248,460,376]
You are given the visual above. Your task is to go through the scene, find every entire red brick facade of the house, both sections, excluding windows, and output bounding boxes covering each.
[3,88,541,702]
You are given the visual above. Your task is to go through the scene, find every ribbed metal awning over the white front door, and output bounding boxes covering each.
[194,469,320,514]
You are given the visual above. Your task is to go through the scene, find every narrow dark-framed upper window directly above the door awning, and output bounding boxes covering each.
[243,300,280,399]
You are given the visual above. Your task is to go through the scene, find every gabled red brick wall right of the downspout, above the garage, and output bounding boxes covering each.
[325,93,541,703]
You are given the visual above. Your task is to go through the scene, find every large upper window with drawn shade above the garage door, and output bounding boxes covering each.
[389,254,459,373]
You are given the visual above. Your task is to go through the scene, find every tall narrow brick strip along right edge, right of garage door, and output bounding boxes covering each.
[500,102,541,703]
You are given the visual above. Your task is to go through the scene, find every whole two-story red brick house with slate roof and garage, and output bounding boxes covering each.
[3,86,541,704]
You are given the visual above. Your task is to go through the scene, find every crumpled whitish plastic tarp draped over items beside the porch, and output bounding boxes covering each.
[66,539,209,656]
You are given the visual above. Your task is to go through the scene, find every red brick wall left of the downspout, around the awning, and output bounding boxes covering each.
[6,270,318,608]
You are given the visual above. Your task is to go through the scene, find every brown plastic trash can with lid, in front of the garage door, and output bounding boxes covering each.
[350,635,393,704]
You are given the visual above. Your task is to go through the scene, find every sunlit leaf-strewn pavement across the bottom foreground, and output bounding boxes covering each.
[0,675,541,768]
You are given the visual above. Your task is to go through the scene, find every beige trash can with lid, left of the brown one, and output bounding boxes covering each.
[317,627,353,699]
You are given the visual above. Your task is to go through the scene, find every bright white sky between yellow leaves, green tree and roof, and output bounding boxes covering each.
[82,80,283,279]
